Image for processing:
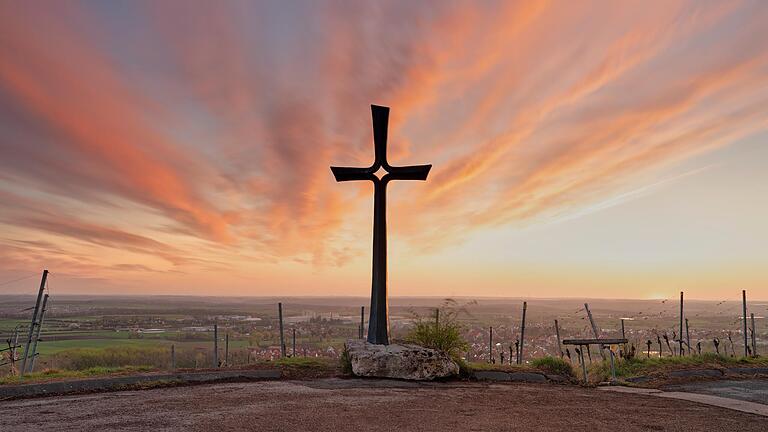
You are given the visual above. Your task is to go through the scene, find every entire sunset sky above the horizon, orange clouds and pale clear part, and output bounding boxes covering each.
[0,0,768,300]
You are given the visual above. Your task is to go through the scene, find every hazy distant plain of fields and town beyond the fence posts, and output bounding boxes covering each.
[0,296,768,373]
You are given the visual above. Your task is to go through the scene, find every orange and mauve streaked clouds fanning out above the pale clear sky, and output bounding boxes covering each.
[0,0,768,296]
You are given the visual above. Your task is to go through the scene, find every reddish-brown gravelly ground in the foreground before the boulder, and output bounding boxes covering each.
[0,378,768,432]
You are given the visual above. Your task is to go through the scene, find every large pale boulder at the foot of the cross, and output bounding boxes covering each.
[347,339,459,381]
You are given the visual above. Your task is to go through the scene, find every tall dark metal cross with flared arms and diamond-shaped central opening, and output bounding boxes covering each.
[331,105,432,345]
